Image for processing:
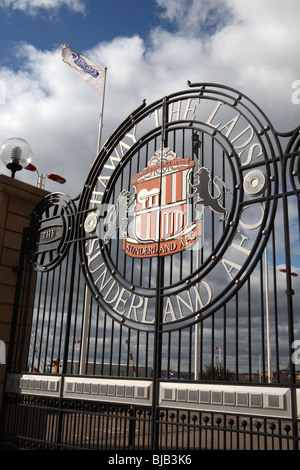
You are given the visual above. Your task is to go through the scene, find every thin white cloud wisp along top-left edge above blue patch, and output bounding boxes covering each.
[0,0,85,15]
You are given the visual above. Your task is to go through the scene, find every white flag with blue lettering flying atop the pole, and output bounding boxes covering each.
[62,44,105,95]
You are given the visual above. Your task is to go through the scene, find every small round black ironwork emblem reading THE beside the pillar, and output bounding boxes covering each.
[27,193,76,272]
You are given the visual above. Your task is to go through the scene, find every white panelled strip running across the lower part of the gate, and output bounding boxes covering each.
[6,374,292,418]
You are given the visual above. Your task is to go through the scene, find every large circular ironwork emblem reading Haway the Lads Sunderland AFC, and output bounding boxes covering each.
[79,84,281,330]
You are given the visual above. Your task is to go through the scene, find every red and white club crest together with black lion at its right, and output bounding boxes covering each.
[123,148,229,258]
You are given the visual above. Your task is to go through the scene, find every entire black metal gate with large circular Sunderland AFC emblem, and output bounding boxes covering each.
[1,83,300,450]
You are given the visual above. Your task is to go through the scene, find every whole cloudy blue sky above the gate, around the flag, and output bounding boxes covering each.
[0,0,300,198]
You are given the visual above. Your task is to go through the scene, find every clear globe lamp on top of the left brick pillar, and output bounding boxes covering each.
[1,137,32,178]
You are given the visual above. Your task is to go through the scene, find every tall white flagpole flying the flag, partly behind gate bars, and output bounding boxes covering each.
[79,67,107,375]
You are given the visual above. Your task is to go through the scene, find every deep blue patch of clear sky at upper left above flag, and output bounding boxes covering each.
[0,0,162,66]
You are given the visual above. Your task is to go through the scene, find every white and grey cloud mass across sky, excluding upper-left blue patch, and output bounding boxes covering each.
[0,0,300,197]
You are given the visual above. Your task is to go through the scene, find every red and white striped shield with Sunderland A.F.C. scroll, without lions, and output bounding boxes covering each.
[123,149,201,258]
